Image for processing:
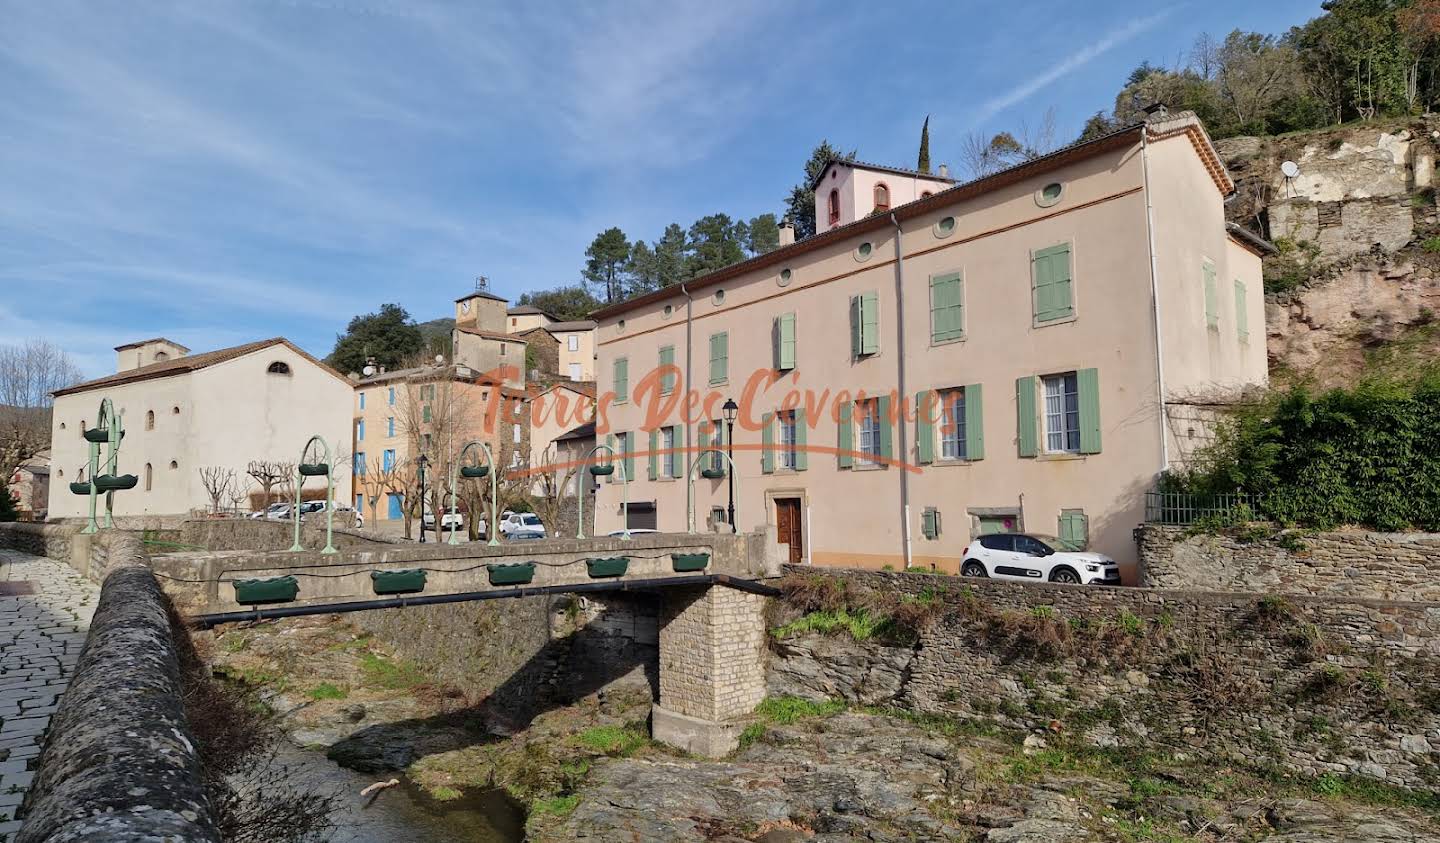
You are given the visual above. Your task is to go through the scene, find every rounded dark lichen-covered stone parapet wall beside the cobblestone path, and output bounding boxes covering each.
[16,530,220,843]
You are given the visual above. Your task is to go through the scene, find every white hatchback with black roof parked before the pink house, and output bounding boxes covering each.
[960,533,1120,585]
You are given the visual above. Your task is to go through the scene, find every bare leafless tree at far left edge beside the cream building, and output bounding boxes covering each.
[0,340,82,477]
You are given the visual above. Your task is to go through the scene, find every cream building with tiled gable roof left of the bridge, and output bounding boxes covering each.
[49,337,351,520]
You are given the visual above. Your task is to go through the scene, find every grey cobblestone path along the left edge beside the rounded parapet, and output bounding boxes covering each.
[0,550,99,843]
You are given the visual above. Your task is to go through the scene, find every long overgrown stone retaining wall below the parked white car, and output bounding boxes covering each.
[768,568,1440,788]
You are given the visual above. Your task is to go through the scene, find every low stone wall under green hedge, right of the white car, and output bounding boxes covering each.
[1139,525,1440,601]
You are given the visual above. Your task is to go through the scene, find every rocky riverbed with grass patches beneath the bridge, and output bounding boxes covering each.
[212,620,1440,843]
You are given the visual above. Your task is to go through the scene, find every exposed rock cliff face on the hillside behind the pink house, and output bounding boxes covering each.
[1217,121,1440,386]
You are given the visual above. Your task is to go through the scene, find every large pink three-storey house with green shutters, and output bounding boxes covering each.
[593,112,1272,582]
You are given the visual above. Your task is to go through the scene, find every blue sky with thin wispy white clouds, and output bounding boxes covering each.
[0,0,1319,376]
